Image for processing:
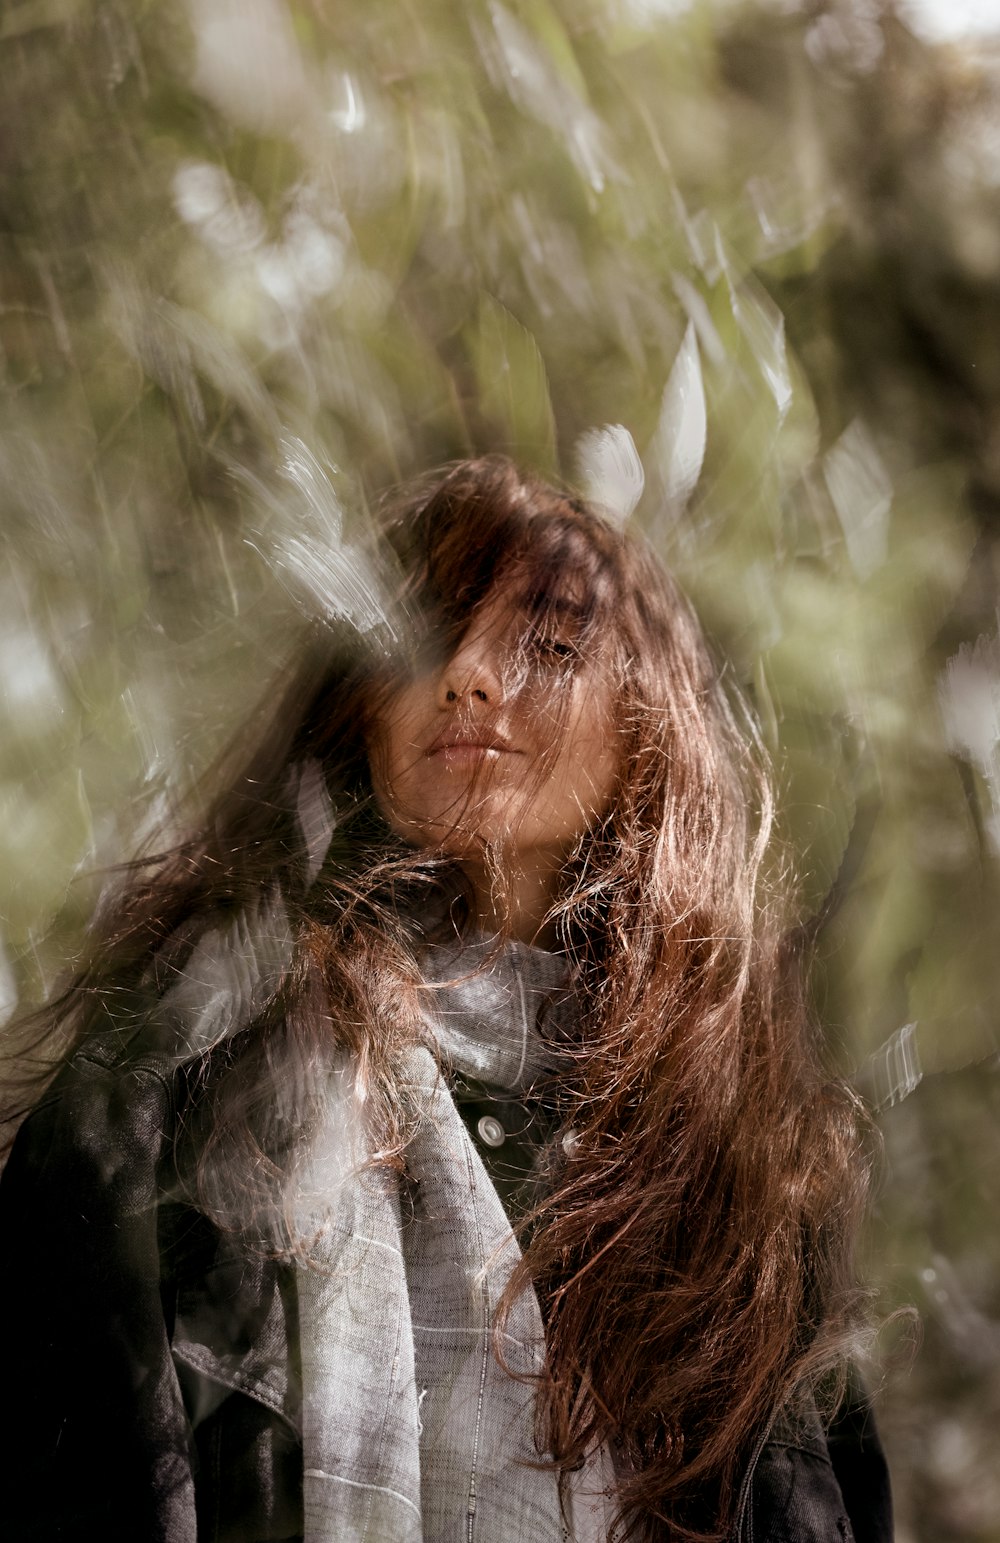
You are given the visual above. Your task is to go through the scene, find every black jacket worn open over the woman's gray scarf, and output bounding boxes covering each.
[0,1038,892,1543]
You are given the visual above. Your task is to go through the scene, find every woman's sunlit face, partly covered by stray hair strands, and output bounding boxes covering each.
[372,579,619,867]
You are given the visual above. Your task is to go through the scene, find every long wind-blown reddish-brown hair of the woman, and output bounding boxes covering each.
[0,457,867,1538]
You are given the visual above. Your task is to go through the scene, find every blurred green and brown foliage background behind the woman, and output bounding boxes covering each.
[0,0,1000,1543]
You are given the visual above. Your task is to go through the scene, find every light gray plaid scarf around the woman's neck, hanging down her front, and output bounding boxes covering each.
[299,943,613,1543]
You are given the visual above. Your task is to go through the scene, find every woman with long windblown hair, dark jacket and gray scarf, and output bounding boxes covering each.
[0,457,890,1543]
